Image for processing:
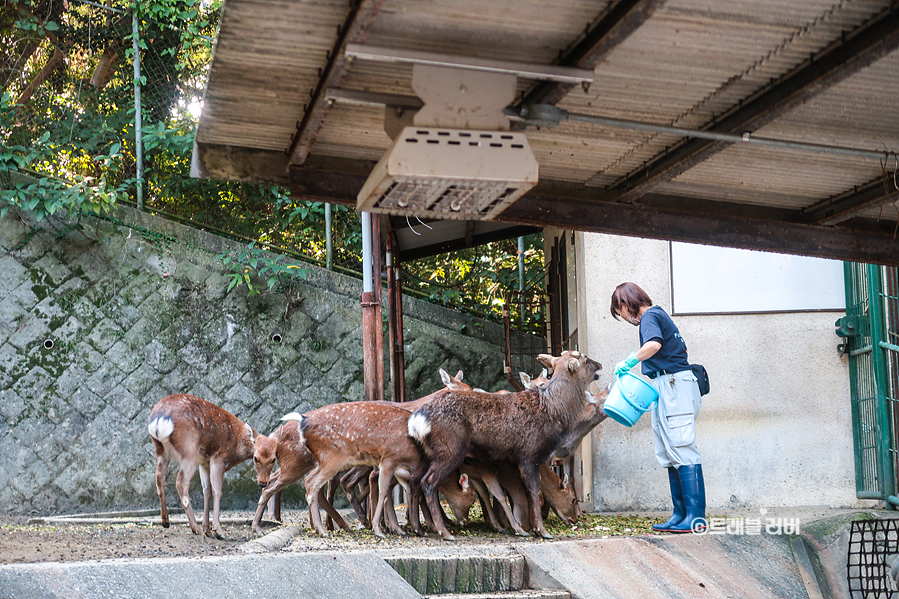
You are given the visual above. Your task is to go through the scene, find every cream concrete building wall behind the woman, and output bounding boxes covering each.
[578,234,871,511]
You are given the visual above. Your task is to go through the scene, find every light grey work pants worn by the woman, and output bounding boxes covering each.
[650,370,702,468]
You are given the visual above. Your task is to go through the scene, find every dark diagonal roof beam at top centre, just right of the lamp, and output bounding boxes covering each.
[520,0,665,105]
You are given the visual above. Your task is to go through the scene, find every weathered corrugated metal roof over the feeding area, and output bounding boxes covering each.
[197,0,899,260]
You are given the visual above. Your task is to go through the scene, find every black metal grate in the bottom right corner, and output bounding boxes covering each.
[846,520,899,599]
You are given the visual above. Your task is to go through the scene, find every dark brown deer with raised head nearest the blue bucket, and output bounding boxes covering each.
[408,351,602,541]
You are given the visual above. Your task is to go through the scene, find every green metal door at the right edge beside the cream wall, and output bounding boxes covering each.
[837,262,899,509]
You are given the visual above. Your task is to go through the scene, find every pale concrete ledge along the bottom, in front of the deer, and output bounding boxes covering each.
[0,507,896,599]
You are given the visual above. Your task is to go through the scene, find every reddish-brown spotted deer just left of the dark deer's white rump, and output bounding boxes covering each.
[282,401,428,538]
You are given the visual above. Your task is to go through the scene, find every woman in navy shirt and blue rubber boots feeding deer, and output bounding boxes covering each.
[611,283,706,532]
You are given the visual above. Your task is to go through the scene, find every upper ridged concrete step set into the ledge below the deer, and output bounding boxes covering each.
[384,555,528,597]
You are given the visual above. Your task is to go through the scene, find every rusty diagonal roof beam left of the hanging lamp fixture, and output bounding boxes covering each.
[287,0,384,165]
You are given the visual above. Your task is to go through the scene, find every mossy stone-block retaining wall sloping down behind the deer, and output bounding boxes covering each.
[0,208,506,514]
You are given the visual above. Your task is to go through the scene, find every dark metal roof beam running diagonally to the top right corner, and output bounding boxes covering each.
[610,5,899,203]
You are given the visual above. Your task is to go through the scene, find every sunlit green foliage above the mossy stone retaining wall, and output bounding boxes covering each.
[0,0,543,320]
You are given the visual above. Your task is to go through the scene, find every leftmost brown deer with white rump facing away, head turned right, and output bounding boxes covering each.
[147,394,274,539]
